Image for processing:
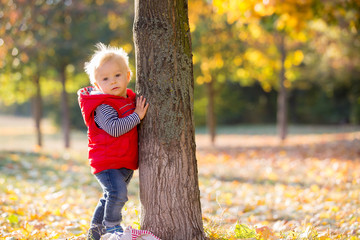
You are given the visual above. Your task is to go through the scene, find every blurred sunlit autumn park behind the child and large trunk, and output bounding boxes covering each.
[0,0,360,240]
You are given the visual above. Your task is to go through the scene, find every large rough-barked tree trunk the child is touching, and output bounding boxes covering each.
[133,0,205,240]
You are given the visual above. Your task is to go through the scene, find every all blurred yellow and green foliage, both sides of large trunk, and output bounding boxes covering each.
[0,0,360,128]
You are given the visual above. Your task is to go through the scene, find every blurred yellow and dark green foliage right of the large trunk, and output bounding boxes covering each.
[190,0,360,124]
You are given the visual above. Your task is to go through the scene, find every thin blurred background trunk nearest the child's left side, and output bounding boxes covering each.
[60,66,70,149]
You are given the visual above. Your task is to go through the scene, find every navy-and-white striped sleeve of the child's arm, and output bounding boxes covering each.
[94,104,140,137]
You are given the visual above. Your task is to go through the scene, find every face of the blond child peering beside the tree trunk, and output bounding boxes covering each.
[94,59,130,98]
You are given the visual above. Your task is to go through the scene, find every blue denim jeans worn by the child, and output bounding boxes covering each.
[91,168,134,227]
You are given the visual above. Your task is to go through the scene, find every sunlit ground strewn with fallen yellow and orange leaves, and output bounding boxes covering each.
[0,132,360,240]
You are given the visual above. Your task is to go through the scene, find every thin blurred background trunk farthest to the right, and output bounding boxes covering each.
[277,35,287,140]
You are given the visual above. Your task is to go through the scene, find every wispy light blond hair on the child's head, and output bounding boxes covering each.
[84,43,132,85]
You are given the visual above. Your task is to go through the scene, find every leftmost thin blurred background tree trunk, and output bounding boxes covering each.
[33,72,42,147]
